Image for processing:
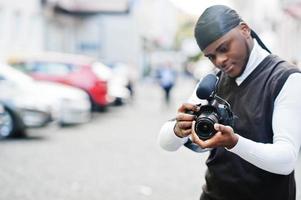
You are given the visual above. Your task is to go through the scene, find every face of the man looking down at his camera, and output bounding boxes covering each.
[203,24,253,78]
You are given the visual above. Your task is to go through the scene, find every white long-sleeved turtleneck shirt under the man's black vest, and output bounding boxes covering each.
[158,40,301,175]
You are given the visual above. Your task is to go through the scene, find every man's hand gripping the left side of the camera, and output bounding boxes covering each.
[174,103,199,138]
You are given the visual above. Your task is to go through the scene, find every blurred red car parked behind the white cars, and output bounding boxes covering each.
[8,52,111,110]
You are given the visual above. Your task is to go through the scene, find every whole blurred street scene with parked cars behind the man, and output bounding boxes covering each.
[0,0,301,200]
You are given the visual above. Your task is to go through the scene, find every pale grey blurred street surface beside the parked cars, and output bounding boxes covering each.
[0,78,301,200]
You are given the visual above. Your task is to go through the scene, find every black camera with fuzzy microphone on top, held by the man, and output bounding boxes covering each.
[192,74,234,140]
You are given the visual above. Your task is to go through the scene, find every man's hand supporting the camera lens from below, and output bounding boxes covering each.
[192,121,238,149]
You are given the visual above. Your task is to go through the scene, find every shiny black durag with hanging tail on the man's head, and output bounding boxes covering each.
[194,5,271,53]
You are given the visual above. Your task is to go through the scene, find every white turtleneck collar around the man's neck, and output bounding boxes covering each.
[235,40,269,85]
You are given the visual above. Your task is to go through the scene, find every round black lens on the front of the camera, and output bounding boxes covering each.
[195,112,218,140]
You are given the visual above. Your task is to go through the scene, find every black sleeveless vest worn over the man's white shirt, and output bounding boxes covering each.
[201,55,299,200]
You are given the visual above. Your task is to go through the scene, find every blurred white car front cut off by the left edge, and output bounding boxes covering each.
[0,65,51,133]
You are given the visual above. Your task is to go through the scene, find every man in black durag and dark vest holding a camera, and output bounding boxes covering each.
[158,5,301,200]
